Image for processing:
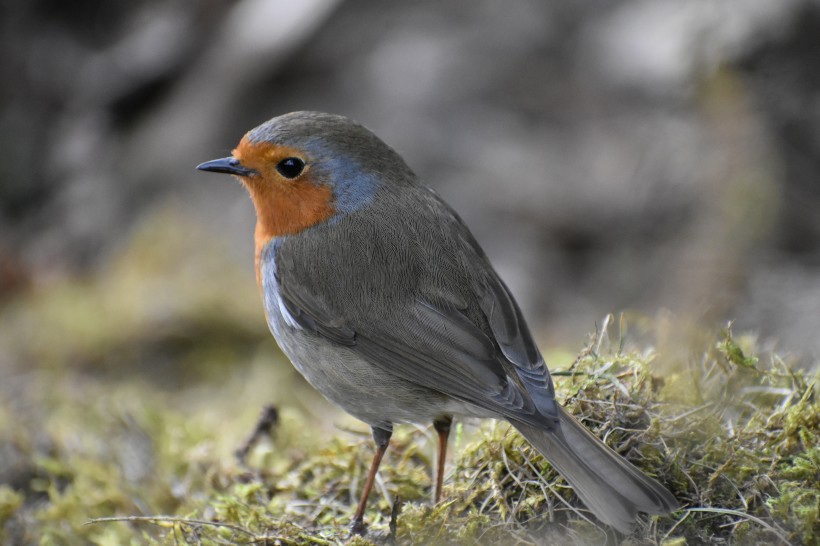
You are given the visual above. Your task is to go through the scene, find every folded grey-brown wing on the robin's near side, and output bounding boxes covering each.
[280,256,557,427]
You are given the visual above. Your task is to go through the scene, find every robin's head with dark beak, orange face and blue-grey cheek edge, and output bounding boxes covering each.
[197,112,415,242]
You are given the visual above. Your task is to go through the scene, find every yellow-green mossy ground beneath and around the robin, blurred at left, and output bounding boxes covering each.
[0,210,820,545]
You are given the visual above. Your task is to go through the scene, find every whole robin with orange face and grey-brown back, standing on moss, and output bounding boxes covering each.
[197,111,678,534]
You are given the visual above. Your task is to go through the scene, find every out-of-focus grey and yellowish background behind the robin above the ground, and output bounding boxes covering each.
[0,0,820,392]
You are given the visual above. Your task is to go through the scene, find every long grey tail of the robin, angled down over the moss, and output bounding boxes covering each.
[513,407,679,533]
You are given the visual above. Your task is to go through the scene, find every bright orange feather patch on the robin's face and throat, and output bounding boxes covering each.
[233,137,335,282]
